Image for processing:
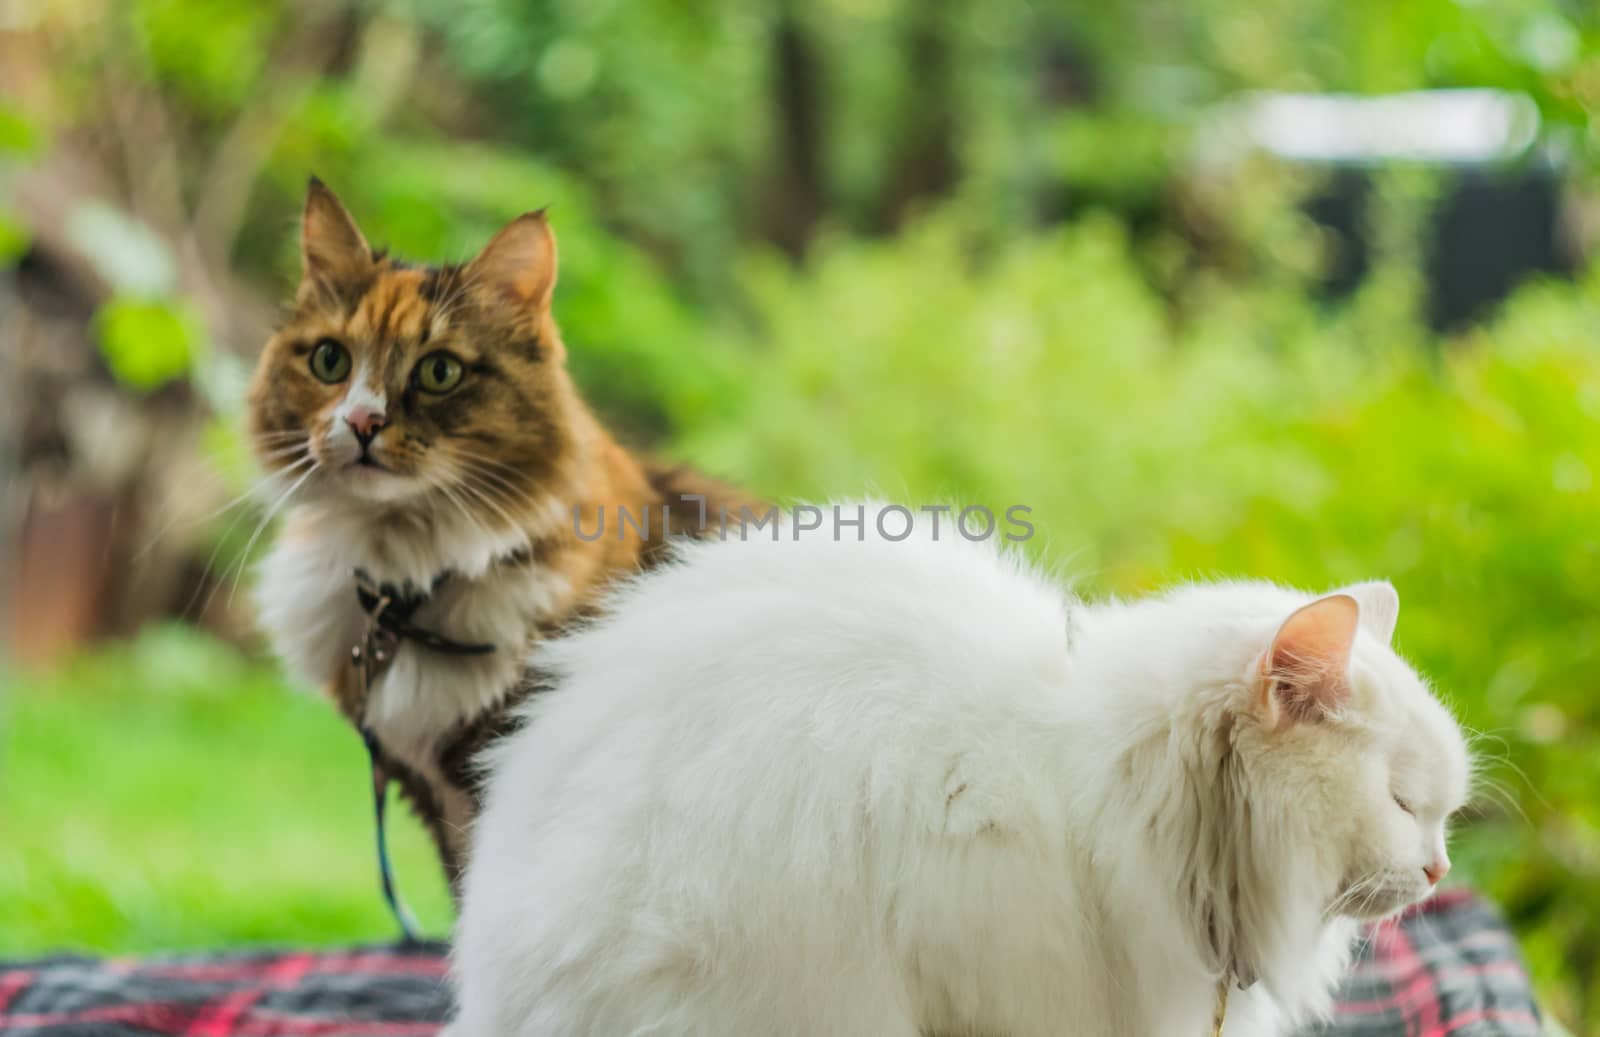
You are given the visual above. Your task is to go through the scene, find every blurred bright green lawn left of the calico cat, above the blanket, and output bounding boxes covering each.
[0,629,450,955]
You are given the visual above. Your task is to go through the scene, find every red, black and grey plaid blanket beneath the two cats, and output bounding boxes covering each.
[0,891,1539,1037]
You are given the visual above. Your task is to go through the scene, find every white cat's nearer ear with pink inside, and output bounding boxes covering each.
[1258,592,1362,728]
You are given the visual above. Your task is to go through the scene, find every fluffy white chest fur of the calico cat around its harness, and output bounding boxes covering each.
[256,510,571,784]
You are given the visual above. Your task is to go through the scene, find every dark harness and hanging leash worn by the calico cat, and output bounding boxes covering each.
[350,570,494,943]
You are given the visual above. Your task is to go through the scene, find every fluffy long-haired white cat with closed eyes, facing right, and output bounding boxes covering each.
[451,522,1469,1037]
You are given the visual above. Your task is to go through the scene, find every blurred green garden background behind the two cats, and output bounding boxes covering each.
[0,0,1600,1032]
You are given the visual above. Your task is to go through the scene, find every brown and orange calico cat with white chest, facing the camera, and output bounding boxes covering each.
[248,179,744,885]
